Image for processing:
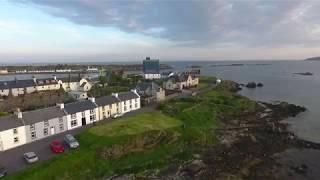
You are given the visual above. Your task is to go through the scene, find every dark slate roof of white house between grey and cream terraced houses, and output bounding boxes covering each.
[64,100,97,114]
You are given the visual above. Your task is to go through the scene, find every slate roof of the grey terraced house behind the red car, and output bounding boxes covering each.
[22,106,65,125]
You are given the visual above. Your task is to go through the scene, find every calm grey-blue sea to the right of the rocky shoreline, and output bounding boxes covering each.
[169,61,320,143]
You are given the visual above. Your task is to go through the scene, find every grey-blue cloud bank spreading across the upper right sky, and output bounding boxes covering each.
[14,0,320,47]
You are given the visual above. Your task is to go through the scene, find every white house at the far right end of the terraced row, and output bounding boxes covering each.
[112,90,140,113]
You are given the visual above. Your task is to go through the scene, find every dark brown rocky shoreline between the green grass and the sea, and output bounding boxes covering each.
[110,83,320,179]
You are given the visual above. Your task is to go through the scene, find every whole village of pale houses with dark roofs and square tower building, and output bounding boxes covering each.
[0,57,210,176]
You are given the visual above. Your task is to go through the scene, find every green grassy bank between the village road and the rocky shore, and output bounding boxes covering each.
[8,81,255,180]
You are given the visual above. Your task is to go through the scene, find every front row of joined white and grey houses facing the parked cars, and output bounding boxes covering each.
[0,90,140,151]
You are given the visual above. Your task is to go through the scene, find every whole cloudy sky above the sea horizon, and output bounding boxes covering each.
[0,0,320,63]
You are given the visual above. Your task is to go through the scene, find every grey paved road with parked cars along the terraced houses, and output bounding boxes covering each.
[0,105,156,174]
